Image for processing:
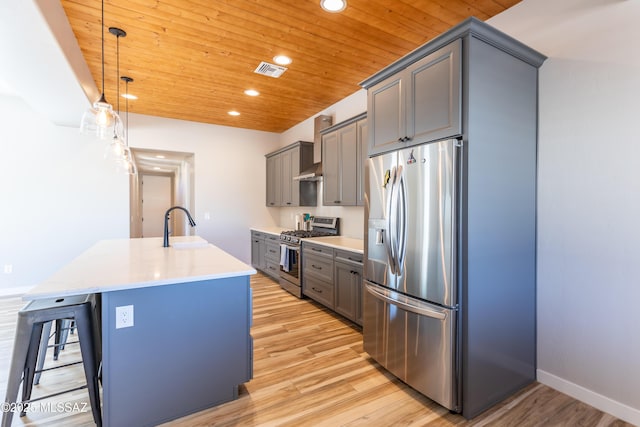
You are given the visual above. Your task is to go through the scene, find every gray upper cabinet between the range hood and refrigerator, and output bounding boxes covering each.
[322,113,367,206]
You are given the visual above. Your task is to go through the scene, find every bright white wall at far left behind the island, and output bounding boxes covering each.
[0,94,129,294]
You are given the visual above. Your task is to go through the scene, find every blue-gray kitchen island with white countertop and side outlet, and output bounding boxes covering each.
[24,236,256,426]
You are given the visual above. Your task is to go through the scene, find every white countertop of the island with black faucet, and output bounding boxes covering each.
[23,236,256,300]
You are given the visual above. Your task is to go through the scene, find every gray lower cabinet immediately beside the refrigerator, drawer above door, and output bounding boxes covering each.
[335,250,362,325]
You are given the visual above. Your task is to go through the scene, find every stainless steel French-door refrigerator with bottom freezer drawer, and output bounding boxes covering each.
[363,139,462,410]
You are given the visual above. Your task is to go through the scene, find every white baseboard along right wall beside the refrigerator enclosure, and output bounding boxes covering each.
[537,369,640,426]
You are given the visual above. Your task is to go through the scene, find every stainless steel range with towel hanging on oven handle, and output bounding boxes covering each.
[280,216,340,298]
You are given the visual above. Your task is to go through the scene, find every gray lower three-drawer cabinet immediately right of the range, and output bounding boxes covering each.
[302,242,335,310]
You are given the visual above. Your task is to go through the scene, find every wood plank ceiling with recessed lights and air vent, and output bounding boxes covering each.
[61,0,519,133]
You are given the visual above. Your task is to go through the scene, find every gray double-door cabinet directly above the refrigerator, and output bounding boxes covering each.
[367,39,462,155]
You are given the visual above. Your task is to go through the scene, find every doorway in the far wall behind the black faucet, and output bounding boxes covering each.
[129,148,196,238]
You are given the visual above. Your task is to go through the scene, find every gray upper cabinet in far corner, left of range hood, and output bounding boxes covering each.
[266,141,317,207]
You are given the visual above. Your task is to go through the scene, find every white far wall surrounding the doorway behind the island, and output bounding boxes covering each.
[129,114,279,263]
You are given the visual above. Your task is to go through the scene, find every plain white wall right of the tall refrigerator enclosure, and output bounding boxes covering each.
[490,0,640,425]
